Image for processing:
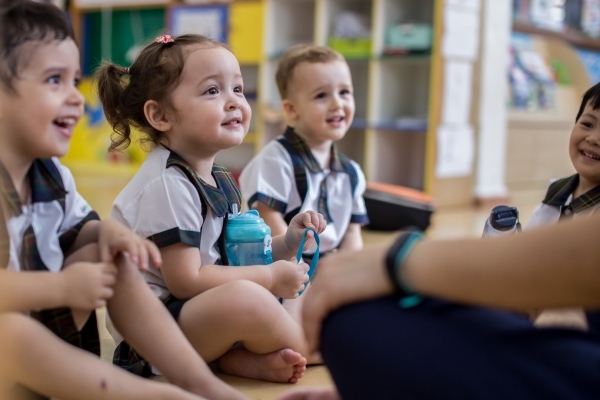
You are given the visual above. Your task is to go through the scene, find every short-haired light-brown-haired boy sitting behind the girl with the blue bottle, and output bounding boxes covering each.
[240,44,368,321]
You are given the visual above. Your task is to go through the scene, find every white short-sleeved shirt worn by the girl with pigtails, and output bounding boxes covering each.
[111,146,237,300]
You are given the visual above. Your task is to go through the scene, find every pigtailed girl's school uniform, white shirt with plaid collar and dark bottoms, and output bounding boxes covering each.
[109,146,241,376]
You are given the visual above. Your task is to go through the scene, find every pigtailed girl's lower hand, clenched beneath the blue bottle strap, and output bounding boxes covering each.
[269,260,310,299]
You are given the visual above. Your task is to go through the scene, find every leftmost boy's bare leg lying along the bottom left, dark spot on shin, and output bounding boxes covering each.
[0,313,205,400]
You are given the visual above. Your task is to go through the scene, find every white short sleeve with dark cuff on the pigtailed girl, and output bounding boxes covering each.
[111,173,203,248]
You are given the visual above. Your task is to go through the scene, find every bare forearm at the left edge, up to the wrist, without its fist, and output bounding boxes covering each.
[0,270,65,312]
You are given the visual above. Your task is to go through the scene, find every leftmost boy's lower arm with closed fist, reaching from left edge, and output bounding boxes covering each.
[0,262,117,312]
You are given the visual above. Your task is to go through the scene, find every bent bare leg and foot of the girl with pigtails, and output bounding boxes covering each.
[179,280,306,383]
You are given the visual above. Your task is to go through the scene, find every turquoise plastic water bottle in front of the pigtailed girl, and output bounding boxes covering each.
[225,204,273,266]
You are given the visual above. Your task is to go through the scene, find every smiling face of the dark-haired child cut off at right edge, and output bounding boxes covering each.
[569,103,600,189]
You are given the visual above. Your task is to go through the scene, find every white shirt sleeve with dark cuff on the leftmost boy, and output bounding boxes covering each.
[52,159,100,253]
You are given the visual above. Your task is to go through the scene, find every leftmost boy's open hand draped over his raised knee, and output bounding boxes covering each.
[98,219,162,271]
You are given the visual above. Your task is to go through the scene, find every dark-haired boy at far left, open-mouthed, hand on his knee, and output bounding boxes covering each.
[0,0,244,400]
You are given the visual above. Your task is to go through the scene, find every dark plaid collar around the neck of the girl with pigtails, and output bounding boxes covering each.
[167,151,242,218]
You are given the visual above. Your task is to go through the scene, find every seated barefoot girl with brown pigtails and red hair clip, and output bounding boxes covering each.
[97,35,326,383]
